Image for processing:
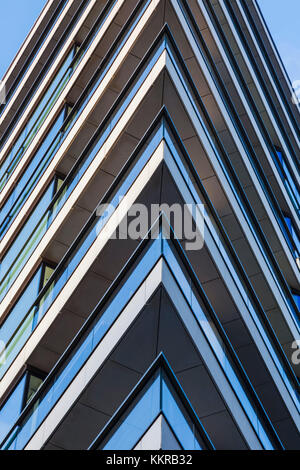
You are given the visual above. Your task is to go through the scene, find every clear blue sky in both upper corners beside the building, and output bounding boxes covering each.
[0,0,300,81]
